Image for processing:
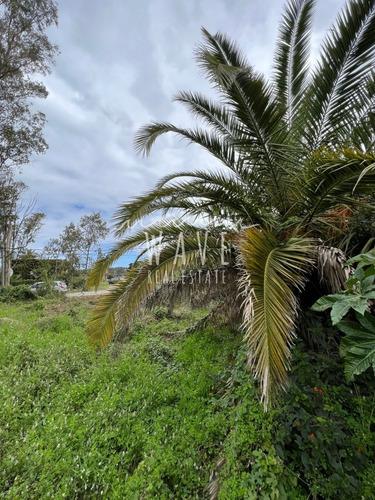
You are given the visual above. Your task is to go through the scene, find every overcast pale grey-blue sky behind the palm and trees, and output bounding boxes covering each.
[22,0,344,266]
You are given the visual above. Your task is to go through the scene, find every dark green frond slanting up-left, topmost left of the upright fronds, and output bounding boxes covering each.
[198,31,285,204]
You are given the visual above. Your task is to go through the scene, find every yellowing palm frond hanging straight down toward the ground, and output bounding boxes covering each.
[238,227,315,408]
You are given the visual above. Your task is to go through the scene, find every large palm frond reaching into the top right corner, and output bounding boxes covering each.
[303,0,375,151]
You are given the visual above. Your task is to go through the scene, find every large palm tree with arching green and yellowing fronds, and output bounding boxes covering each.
[88,0,375,405]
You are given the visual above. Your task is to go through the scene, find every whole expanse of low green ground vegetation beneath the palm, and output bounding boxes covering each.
[0,298,375,500]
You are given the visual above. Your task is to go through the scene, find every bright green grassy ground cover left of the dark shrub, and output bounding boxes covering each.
[0,302,236,498]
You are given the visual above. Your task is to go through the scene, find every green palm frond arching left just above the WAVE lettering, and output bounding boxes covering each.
[112,167,269,237]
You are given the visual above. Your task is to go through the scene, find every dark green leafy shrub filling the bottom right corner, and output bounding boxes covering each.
[274,344,375,499]
